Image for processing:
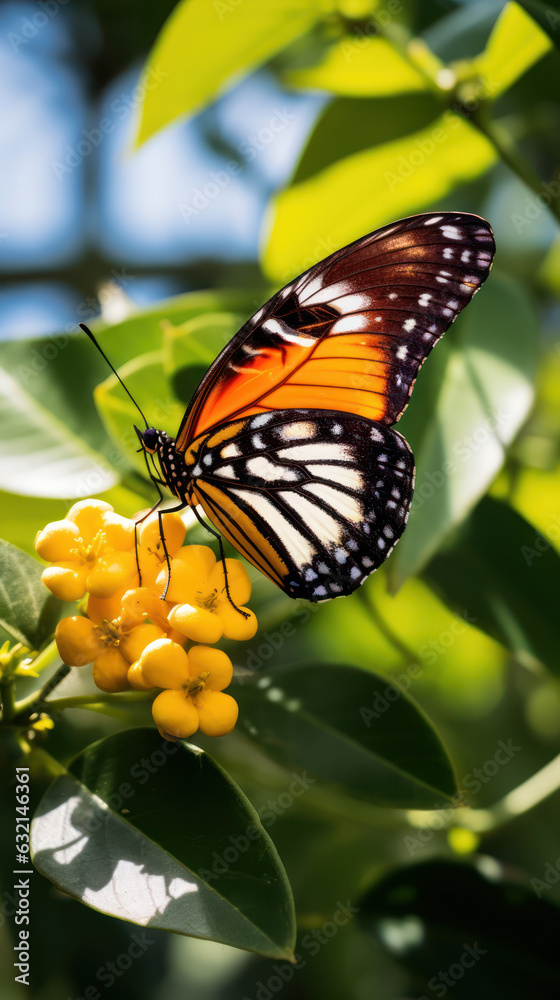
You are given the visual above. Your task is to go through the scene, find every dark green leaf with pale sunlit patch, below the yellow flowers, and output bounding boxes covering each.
[31,729,295,959]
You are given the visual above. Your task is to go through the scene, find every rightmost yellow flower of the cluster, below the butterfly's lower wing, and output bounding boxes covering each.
[161,545,257,643]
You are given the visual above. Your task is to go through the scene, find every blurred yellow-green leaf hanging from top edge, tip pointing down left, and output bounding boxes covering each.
[136,0,331,145]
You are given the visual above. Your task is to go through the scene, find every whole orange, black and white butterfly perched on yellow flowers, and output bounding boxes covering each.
[118,212,495,602]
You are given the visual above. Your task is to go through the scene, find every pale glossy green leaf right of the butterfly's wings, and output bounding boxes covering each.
[391,274,537,585]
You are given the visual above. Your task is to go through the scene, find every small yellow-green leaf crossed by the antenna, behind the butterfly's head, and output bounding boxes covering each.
[94,351,185,473]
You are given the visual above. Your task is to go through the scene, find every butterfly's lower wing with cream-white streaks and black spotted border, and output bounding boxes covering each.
[185,409,414,601]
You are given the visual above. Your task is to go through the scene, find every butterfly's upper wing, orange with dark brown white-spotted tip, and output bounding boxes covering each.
[177,212,495,452]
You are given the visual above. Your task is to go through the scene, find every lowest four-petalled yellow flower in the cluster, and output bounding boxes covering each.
[148,640,238,739]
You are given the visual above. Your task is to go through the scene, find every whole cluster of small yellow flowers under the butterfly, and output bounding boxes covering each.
[35,500,257,739]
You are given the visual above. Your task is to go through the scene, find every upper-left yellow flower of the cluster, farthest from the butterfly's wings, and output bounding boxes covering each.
[35,500,138,601]
